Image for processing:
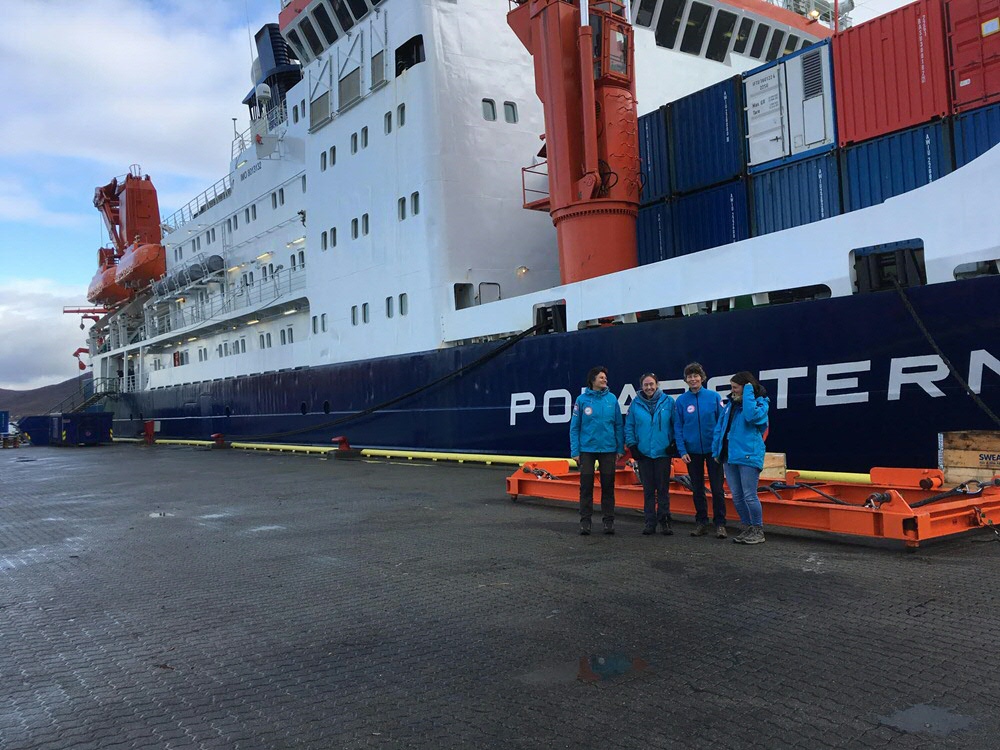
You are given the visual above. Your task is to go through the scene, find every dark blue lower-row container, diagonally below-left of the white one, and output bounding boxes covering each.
[674,180,750,255]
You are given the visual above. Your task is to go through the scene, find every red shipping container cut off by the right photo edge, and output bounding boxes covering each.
[945,0,1000,112]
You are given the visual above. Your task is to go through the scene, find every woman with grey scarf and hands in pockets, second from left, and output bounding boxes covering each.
[625,372,674,536]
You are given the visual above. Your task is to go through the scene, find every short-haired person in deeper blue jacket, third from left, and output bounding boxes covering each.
[674,362,726,539]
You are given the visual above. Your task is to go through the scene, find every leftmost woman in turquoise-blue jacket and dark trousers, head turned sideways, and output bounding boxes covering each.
[569,366,625,535]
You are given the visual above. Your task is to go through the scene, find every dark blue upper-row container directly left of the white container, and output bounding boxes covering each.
[667,76,746,193]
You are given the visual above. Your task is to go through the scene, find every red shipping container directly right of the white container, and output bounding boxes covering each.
[833,0,951,146]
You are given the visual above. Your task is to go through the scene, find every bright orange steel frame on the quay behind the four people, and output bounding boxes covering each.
[507,459,1000,549]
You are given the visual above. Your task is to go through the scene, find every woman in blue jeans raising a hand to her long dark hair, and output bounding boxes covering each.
[712,371,771,544]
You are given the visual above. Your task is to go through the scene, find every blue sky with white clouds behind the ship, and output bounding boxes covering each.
[0,0,903,389]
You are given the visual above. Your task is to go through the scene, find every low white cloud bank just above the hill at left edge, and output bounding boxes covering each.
[0,279,92,390]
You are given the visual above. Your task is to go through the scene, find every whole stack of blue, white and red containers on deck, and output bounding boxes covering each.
[639,0,1000,264]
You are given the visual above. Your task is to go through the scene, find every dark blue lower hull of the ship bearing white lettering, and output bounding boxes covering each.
[115,276,1000,471]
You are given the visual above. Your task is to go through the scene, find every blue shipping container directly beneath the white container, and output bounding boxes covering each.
[750,153,841,237]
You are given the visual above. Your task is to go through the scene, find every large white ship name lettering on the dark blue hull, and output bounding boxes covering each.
[510,349,1000,427]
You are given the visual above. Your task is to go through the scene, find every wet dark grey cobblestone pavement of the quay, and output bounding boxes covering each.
[0,446,1000,750]
